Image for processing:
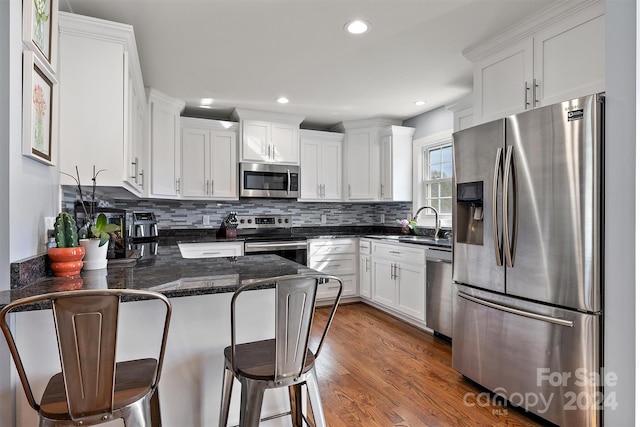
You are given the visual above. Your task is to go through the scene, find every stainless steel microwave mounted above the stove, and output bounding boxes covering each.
[240,163,300,199]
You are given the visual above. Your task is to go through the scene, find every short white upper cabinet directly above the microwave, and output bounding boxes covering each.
[232,109,304,165]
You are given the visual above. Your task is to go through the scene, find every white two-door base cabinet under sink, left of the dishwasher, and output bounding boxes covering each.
[370,242,427,324]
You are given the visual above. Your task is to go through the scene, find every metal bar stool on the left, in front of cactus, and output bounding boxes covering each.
[0,289,171,427]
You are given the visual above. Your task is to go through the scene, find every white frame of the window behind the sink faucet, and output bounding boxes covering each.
[413,130,453,228]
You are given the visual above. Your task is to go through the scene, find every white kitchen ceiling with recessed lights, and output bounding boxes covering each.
[60,0,553,129]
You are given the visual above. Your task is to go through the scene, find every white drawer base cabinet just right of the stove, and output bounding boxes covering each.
[307,238,358,300]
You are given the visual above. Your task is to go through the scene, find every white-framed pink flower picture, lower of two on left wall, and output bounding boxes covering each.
[22,50,58,166]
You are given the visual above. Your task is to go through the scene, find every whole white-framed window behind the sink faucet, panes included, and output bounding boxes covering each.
[413,131,453,228]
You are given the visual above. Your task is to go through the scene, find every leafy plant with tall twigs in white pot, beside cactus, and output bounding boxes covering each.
[61,166,120,270]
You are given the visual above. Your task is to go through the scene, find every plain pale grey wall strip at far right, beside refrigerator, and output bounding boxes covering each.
[604,0,640,426]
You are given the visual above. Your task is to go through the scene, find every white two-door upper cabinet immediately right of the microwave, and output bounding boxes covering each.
[298,130,344,202]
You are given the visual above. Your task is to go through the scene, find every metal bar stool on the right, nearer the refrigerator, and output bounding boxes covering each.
[219,275,342,427]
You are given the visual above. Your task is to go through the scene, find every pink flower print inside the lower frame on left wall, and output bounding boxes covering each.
[31,67,51,159]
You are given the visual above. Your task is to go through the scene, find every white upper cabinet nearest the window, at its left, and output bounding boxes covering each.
[380,126,415,202]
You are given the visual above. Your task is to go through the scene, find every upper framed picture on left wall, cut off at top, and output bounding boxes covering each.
[22,0,58,73]
